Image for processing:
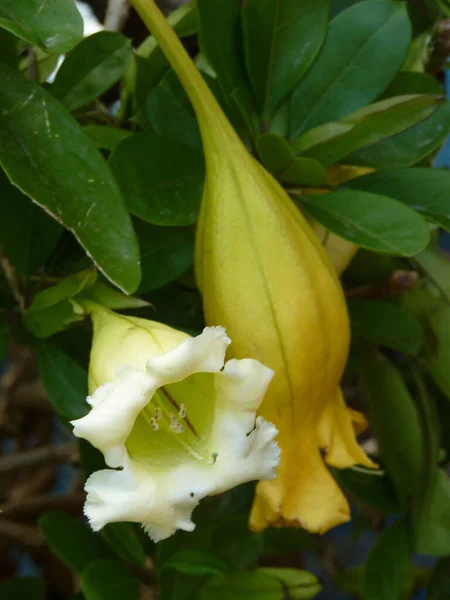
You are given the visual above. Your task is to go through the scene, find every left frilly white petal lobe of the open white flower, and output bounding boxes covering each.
[71,367,158,467]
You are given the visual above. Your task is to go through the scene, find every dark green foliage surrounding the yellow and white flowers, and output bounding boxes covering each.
[0,0,450,600]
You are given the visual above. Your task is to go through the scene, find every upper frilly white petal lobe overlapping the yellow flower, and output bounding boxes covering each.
[147,327,230,385]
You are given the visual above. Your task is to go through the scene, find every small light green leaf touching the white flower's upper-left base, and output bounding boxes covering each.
[22,269,97,338]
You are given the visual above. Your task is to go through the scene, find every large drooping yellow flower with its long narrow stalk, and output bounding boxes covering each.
[132,0,372,532]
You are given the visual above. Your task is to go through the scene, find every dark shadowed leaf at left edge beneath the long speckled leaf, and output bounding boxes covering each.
[0,169,63,275]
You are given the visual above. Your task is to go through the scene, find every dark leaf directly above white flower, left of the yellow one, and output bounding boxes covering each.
[135,221,194,293]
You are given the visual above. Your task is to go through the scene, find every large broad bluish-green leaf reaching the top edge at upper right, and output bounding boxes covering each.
[290,0,410,139]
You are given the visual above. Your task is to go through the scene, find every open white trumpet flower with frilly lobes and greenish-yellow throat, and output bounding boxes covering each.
[72,318,280,541]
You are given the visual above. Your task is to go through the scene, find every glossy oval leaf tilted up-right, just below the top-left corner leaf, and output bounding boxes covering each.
[51,31,131,110]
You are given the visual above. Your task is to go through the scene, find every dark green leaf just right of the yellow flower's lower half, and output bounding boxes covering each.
[348,300,423,356]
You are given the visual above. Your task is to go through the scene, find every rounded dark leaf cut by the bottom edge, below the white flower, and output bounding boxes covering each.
[81,560,139,600]
